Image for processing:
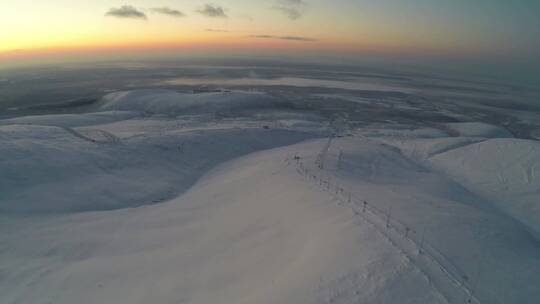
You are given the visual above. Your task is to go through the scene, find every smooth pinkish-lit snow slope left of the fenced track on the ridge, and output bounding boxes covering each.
[0,141,456,303]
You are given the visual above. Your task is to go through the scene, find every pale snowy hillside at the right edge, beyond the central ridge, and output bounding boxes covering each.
[429,139,540,235]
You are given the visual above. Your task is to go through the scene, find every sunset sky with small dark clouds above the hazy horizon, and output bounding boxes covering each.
[0,0,540,66]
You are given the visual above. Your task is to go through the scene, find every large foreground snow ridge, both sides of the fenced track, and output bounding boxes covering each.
[0,139,540,303]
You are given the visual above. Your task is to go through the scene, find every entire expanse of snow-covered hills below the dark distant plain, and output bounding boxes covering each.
[0,90,540,304]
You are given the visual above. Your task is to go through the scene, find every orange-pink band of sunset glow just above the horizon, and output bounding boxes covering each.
[0,37,494,65]
